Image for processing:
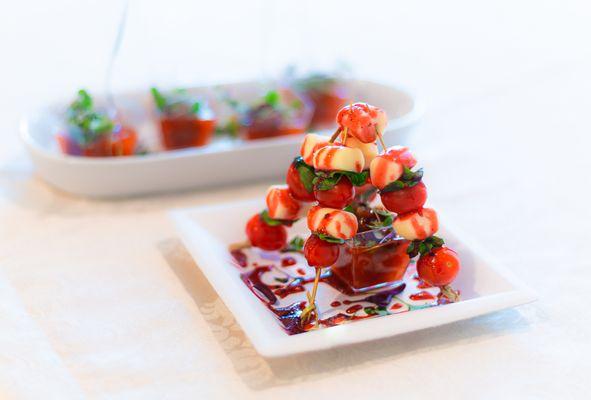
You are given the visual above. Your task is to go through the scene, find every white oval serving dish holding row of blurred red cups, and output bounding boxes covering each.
[20,80,422,197]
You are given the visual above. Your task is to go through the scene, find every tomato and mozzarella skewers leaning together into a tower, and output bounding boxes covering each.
[246,103,460,323]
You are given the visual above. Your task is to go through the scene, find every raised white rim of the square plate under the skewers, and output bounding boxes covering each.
[168,197,538,358]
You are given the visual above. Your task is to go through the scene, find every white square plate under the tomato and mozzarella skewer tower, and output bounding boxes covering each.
[171,200,536,357]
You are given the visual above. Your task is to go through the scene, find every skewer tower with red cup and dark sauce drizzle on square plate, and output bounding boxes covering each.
[231,103,460,334]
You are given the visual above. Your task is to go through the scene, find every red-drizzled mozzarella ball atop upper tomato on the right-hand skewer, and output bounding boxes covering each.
[369,146,417,189]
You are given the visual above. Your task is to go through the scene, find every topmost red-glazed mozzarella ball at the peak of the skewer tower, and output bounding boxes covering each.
[337,103,388,143]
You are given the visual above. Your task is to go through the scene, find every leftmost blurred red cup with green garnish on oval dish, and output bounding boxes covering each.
[56,90,138,157]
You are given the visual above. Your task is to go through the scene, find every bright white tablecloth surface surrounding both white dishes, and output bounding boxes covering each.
[0,0,591,399]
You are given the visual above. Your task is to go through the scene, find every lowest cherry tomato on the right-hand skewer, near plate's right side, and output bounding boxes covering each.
[417,247,460,286]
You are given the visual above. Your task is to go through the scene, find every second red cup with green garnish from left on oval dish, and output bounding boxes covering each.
[151,87,216,150]
